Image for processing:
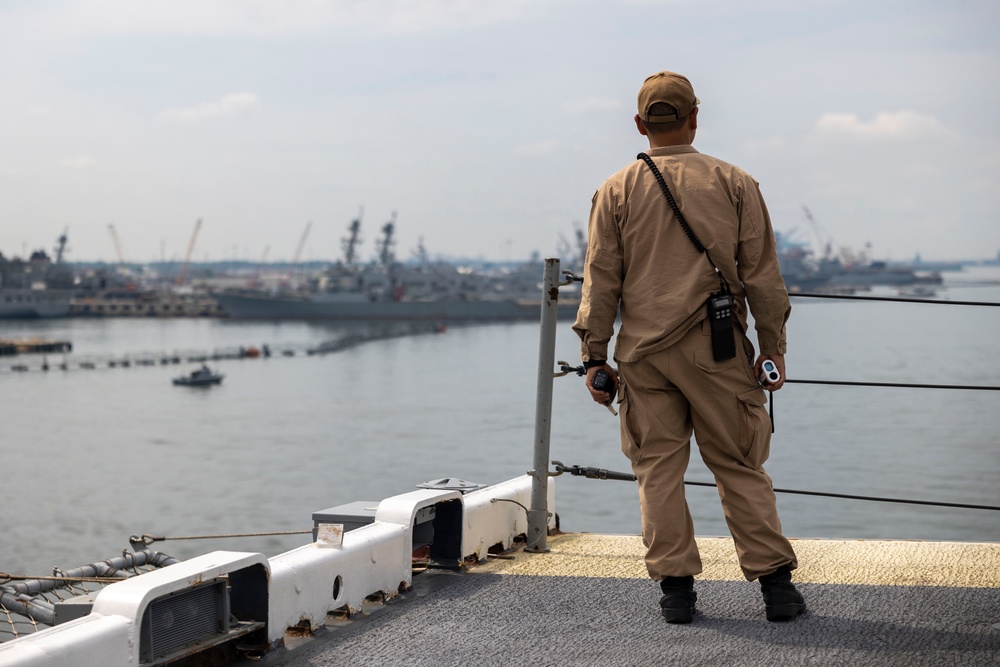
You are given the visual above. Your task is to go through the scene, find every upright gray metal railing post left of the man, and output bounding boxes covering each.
[525,258,559,552]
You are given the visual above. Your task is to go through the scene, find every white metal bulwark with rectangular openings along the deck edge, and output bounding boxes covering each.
[0,475,555,667]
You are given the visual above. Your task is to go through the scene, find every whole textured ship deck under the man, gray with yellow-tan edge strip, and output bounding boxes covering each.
[245,534,1000,667]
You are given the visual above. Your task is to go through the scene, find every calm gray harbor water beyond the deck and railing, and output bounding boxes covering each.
[0,268,1000,574]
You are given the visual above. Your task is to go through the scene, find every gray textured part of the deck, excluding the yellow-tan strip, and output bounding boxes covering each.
[248,573,1000,667]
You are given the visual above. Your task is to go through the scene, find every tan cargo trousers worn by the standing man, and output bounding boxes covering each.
[619,320,797,581]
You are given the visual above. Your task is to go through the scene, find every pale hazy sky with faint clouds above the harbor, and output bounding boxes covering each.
[0,0,1000,262]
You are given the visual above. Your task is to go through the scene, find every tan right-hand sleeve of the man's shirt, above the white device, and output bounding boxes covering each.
[737,176,791,354]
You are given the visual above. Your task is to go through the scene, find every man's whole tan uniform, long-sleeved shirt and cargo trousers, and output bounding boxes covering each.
[573,146,796,580]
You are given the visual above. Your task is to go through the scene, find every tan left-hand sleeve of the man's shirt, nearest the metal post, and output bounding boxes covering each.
[573,182,622,361]
